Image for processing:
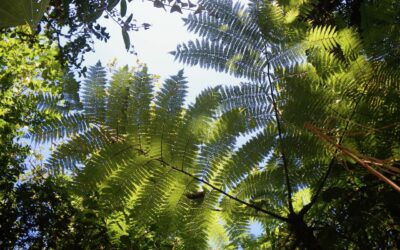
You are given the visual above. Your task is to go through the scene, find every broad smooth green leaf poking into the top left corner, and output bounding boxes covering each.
[0,0,50,31]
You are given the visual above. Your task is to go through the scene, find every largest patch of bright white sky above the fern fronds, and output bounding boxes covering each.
[86,1,241,102]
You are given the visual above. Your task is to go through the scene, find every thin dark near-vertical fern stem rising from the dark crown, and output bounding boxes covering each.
[267,62,295,214]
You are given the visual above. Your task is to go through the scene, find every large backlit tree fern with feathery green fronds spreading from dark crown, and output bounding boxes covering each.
[32,0,399,249]
